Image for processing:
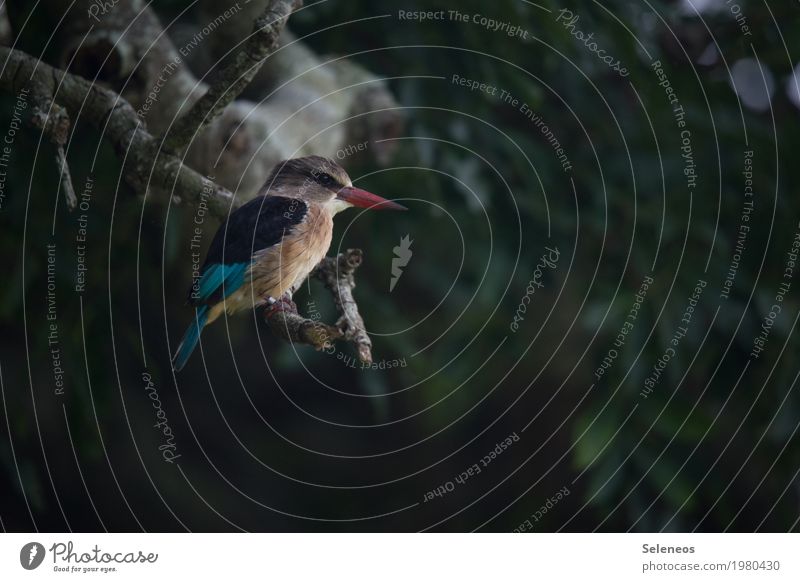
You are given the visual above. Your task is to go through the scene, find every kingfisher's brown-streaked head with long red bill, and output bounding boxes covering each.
[260,156,406,214]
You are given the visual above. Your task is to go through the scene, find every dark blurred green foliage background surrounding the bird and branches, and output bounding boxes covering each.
[0,0,800,531]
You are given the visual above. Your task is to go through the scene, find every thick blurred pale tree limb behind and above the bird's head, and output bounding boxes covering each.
[39,0,404,196]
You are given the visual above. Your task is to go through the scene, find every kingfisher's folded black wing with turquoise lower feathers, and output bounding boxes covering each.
[189,196,308,305]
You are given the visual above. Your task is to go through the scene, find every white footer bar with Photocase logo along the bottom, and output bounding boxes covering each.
[0,534,800,582]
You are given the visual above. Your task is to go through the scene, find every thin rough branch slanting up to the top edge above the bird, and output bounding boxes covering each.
[164,0,303,151]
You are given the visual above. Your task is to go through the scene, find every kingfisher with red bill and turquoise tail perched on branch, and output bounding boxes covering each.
[172,156,405,371]
